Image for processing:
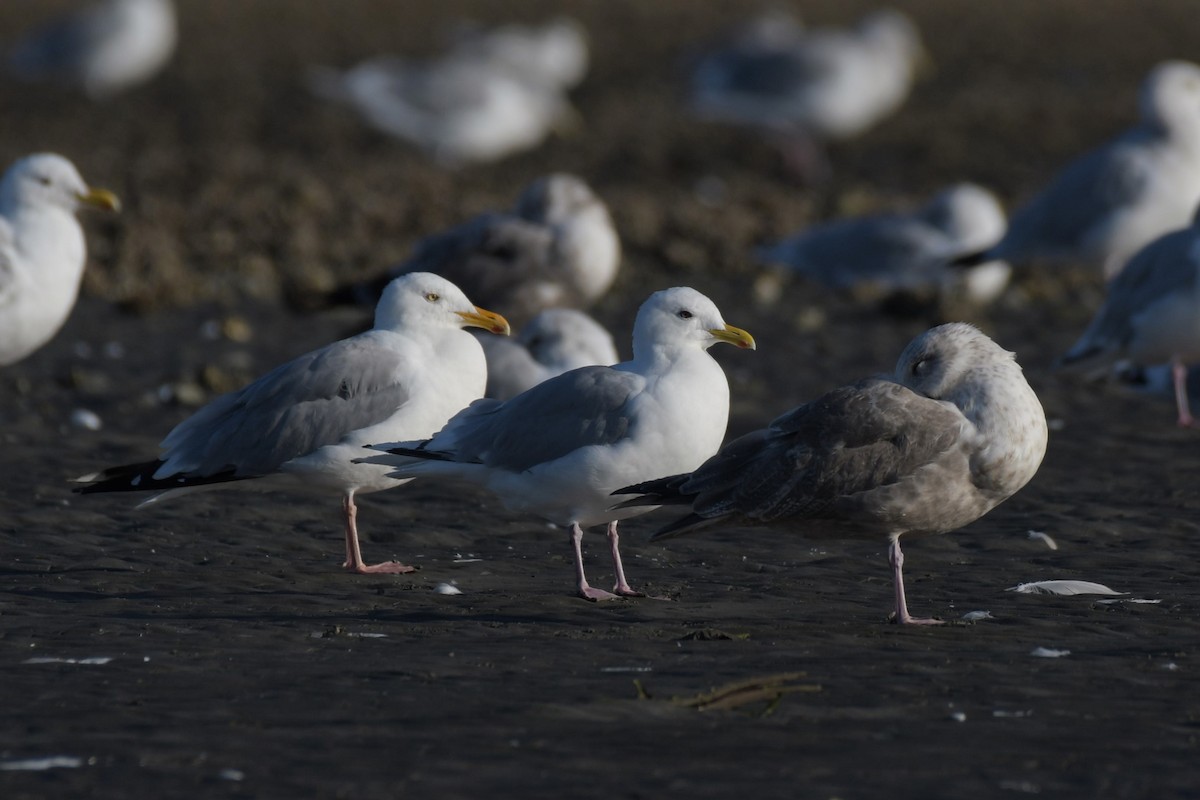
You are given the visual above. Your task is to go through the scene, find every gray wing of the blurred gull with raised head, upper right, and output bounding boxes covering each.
[992,132,1154,260]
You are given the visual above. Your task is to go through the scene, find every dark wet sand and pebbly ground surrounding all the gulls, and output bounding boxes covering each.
[0,0,1200,800]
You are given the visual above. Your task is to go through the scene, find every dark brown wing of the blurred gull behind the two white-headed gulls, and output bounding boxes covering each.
[396,213,554,321]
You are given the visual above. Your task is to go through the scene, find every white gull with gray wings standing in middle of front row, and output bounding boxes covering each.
[355,288,755,600]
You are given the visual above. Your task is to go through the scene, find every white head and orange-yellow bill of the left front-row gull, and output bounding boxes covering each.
[374,272,509,336]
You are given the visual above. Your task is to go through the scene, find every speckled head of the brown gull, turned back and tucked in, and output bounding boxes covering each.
[895,323,1020,400]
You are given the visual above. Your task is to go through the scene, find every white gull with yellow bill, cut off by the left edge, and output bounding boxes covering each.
[0,152,120,367]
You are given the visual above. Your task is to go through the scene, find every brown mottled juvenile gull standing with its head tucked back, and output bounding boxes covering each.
[620,323,1046,624]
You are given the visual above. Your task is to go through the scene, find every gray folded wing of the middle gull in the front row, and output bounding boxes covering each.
[427,367,646,473]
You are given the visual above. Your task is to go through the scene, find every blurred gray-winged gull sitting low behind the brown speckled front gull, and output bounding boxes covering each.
[758,184,1012,303]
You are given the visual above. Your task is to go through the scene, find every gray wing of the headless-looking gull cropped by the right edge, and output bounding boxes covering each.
[1063,227,1200,362]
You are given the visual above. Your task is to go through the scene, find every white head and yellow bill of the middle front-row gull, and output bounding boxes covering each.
[634,287,755,360]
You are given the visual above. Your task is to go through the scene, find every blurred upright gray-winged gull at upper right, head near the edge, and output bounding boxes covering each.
[968,61,1200,279]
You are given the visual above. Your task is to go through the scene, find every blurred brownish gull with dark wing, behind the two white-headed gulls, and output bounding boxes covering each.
[334,173,620,325]
